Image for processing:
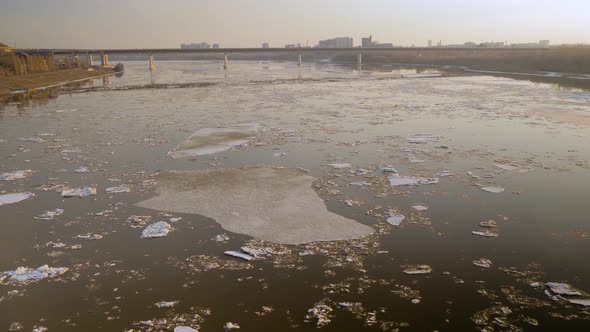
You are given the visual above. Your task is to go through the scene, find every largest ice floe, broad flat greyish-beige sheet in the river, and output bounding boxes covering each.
[138,167,373,244]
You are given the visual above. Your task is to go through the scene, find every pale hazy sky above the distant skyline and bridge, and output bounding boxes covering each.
[0,0,590,48]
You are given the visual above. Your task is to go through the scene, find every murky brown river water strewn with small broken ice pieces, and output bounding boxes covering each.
[0,61,590,331]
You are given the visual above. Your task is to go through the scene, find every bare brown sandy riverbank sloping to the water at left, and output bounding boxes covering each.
[0,68,114,100]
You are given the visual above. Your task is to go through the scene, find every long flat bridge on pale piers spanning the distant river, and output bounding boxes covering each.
[18,47,549,71]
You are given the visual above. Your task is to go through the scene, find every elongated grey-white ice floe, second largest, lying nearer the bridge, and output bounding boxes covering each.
[168,123,260,158]
